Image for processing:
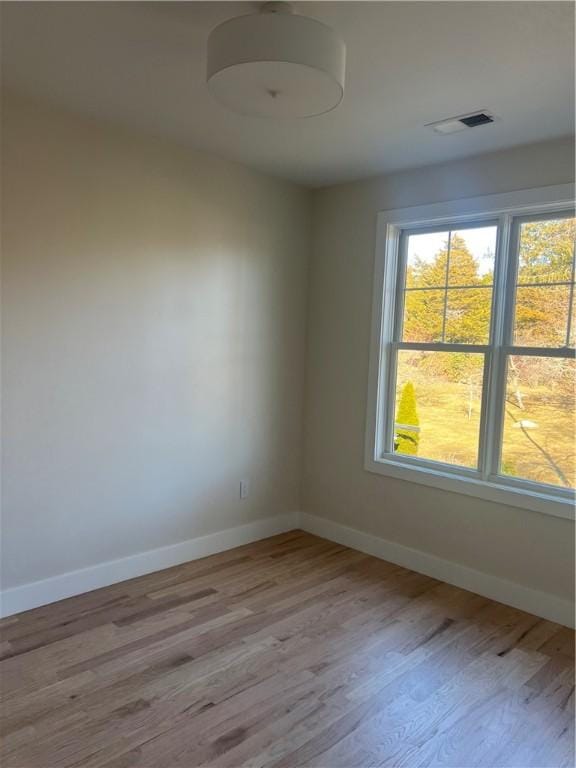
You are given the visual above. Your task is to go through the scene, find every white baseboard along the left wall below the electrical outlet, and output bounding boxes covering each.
[0,512,300,616]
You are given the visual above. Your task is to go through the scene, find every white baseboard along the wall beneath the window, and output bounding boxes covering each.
[300,513,574,627]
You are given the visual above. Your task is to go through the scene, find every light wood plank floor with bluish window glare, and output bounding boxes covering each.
[0,531,574,768]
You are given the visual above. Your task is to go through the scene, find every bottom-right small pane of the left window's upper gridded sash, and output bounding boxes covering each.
[444,288,492,344]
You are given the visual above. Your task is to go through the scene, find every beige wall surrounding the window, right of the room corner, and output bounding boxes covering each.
[303,138,574,597]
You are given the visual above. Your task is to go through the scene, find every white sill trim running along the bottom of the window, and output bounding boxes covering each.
[365,458,575,520]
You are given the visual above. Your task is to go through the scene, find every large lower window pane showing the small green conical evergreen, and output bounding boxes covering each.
[394,350,484,468]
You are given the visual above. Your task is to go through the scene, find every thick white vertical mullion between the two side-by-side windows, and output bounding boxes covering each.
[478,214,517,479]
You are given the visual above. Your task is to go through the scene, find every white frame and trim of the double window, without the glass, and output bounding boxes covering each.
[364,184,575,520]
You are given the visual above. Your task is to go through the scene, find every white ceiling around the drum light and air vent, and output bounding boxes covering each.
[2,0,574,186]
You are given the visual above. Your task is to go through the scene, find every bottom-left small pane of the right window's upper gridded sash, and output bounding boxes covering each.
[514,285,570,347]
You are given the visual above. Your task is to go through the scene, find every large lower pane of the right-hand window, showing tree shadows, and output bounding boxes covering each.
[501,355,576,487]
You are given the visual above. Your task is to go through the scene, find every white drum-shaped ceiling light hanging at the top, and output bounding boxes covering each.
[207,3,346,117]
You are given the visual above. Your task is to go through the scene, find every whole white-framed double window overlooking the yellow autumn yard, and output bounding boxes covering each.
[367,188,576,516]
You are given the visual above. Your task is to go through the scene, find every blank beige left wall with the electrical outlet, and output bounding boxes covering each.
[2,95,310,588]
